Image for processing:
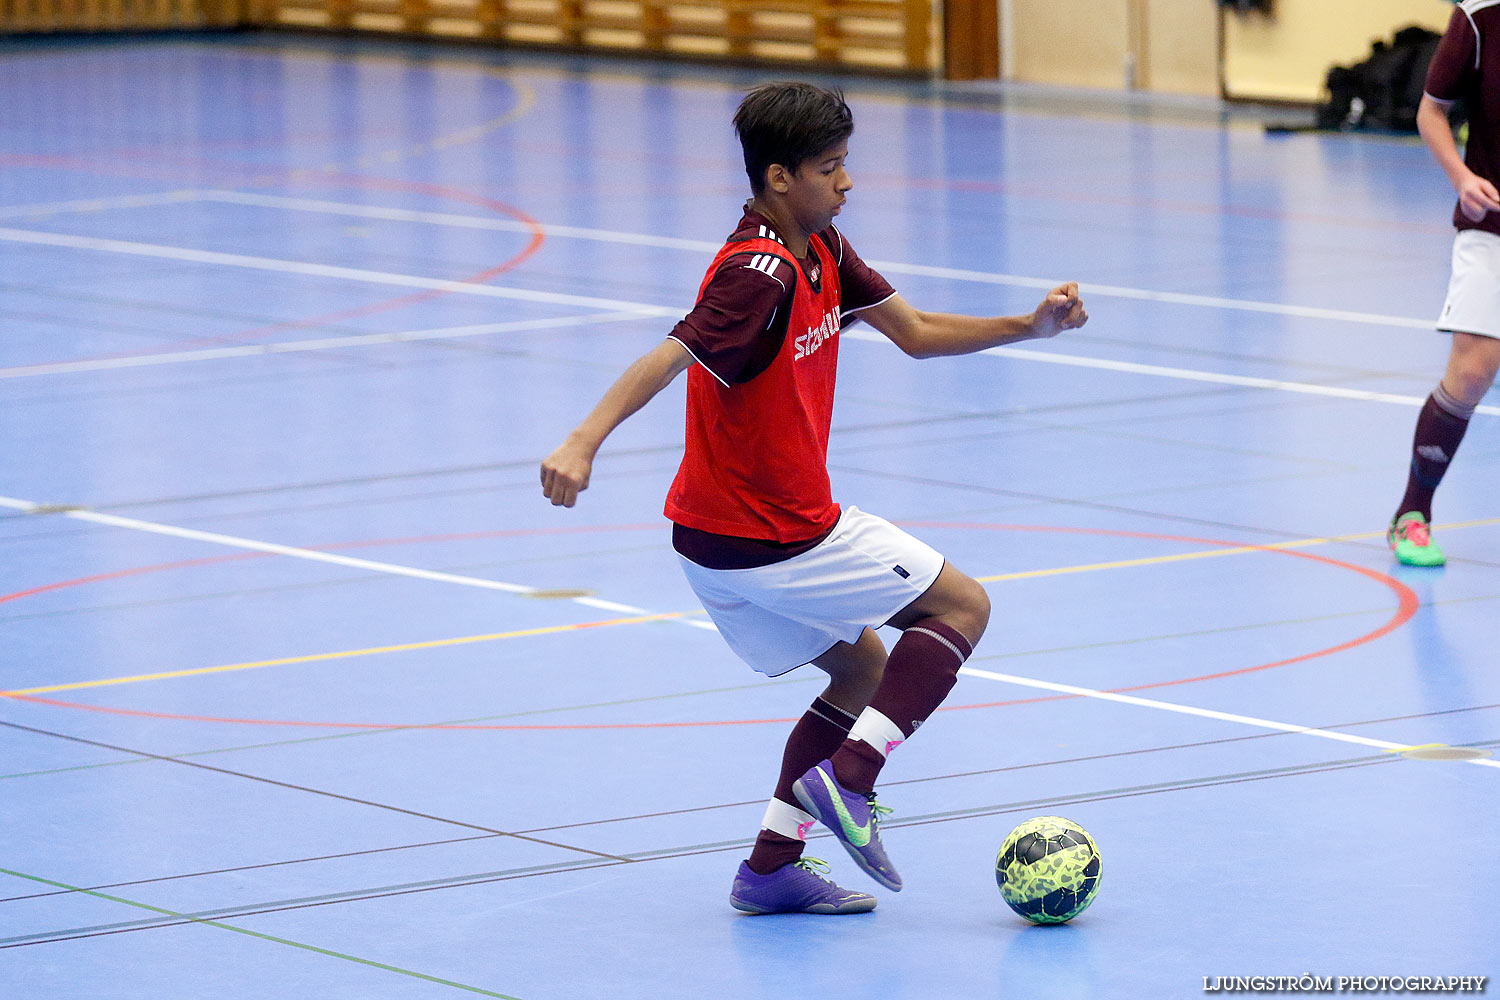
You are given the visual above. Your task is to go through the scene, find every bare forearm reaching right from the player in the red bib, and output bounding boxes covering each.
[860,282,1089,358]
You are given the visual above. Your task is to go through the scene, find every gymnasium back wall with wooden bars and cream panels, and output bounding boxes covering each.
[0,0,1452,95]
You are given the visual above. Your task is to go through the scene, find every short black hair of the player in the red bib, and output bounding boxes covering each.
[735,82,854,195]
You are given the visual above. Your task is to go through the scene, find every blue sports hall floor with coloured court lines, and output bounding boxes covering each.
[0,34,1500,1000]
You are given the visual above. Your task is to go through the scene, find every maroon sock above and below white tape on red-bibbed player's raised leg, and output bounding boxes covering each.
[833,618,974,793]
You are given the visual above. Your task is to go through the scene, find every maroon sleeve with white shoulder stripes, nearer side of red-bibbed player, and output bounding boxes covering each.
[668,253,795,385]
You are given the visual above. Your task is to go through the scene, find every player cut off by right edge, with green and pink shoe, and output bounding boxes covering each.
[1386,0,1500,567]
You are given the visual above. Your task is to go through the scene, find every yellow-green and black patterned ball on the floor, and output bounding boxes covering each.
[995,816,1100,924]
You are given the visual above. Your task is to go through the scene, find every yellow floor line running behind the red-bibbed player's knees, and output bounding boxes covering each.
[11,517,1500,697]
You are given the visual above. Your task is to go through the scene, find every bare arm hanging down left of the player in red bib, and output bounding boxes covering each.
[542,339,693,507]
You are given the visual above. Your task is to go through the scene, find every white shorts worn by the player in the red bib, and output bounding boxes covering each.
[678,507,944,678]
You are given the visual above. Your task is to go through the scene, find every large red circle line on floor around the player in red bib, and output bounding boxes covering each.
[0,522,1421,732]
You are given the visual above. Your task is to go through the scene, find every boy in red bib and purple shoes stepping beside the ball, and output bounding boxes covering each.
[542,82,1088,913]
